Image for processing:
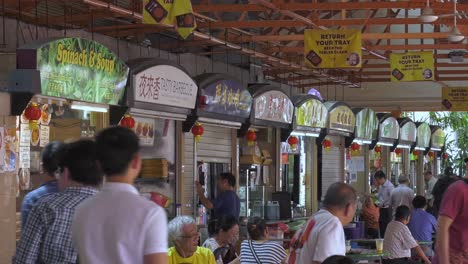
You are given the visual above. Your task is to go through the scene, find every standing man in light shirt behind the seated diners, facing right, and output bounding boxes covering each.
[374,171,395,236]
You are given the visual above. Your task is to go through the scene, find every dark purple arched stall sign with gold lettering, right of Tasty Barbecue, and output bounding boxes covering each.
[184,73,252,131]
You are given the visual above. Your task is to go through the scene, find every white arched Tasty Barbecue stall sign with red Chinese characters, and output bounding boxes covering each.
[126,58,198,120]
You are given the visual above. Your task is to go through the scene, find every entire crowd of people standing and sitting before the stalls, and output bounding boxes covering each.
[13,127,468,264]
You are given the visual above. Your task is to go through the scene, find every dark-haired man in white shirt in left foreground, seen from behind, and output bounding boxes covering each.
[72,127,168,264]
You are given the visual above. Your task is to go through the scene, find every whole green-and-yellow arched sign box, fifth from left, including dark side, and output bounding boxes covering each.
[288,94,328,137]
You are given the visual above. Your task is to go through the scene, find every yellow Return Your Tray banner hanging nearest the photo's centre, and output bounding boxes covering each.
[304,29,362,68]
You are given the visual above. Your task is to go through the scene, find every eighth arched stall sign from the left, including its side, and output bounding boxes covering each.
[370,113,400,149]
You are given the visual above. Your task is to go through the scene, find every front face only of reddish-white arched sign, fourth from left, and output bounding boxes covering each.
[254,90,294,124]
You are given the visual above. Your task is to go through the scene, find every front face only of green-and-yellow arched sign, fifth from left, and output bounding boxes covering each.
[295,99,328,128]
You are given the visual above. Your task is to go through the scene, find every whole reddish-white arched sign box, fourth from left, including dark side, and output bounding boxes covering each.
[239,84,294,136]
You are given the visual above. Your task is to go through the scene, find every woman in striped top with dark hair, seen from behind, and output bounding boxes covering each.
[240,217,286,264]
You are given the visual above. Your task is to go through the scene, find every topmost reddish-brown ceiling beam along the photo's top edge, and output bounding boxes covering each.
[194,0,468,13]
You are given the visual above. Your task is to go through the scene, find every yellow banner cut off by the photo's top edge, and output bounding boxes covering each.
[143,0,197,39]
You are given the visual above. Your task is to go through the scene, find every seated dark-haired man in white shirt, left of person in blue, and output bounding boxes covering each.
[383,205,431,264]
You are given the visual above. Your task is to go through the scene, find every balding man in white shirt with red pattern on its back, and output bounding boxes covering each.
[288,182,357,264]
